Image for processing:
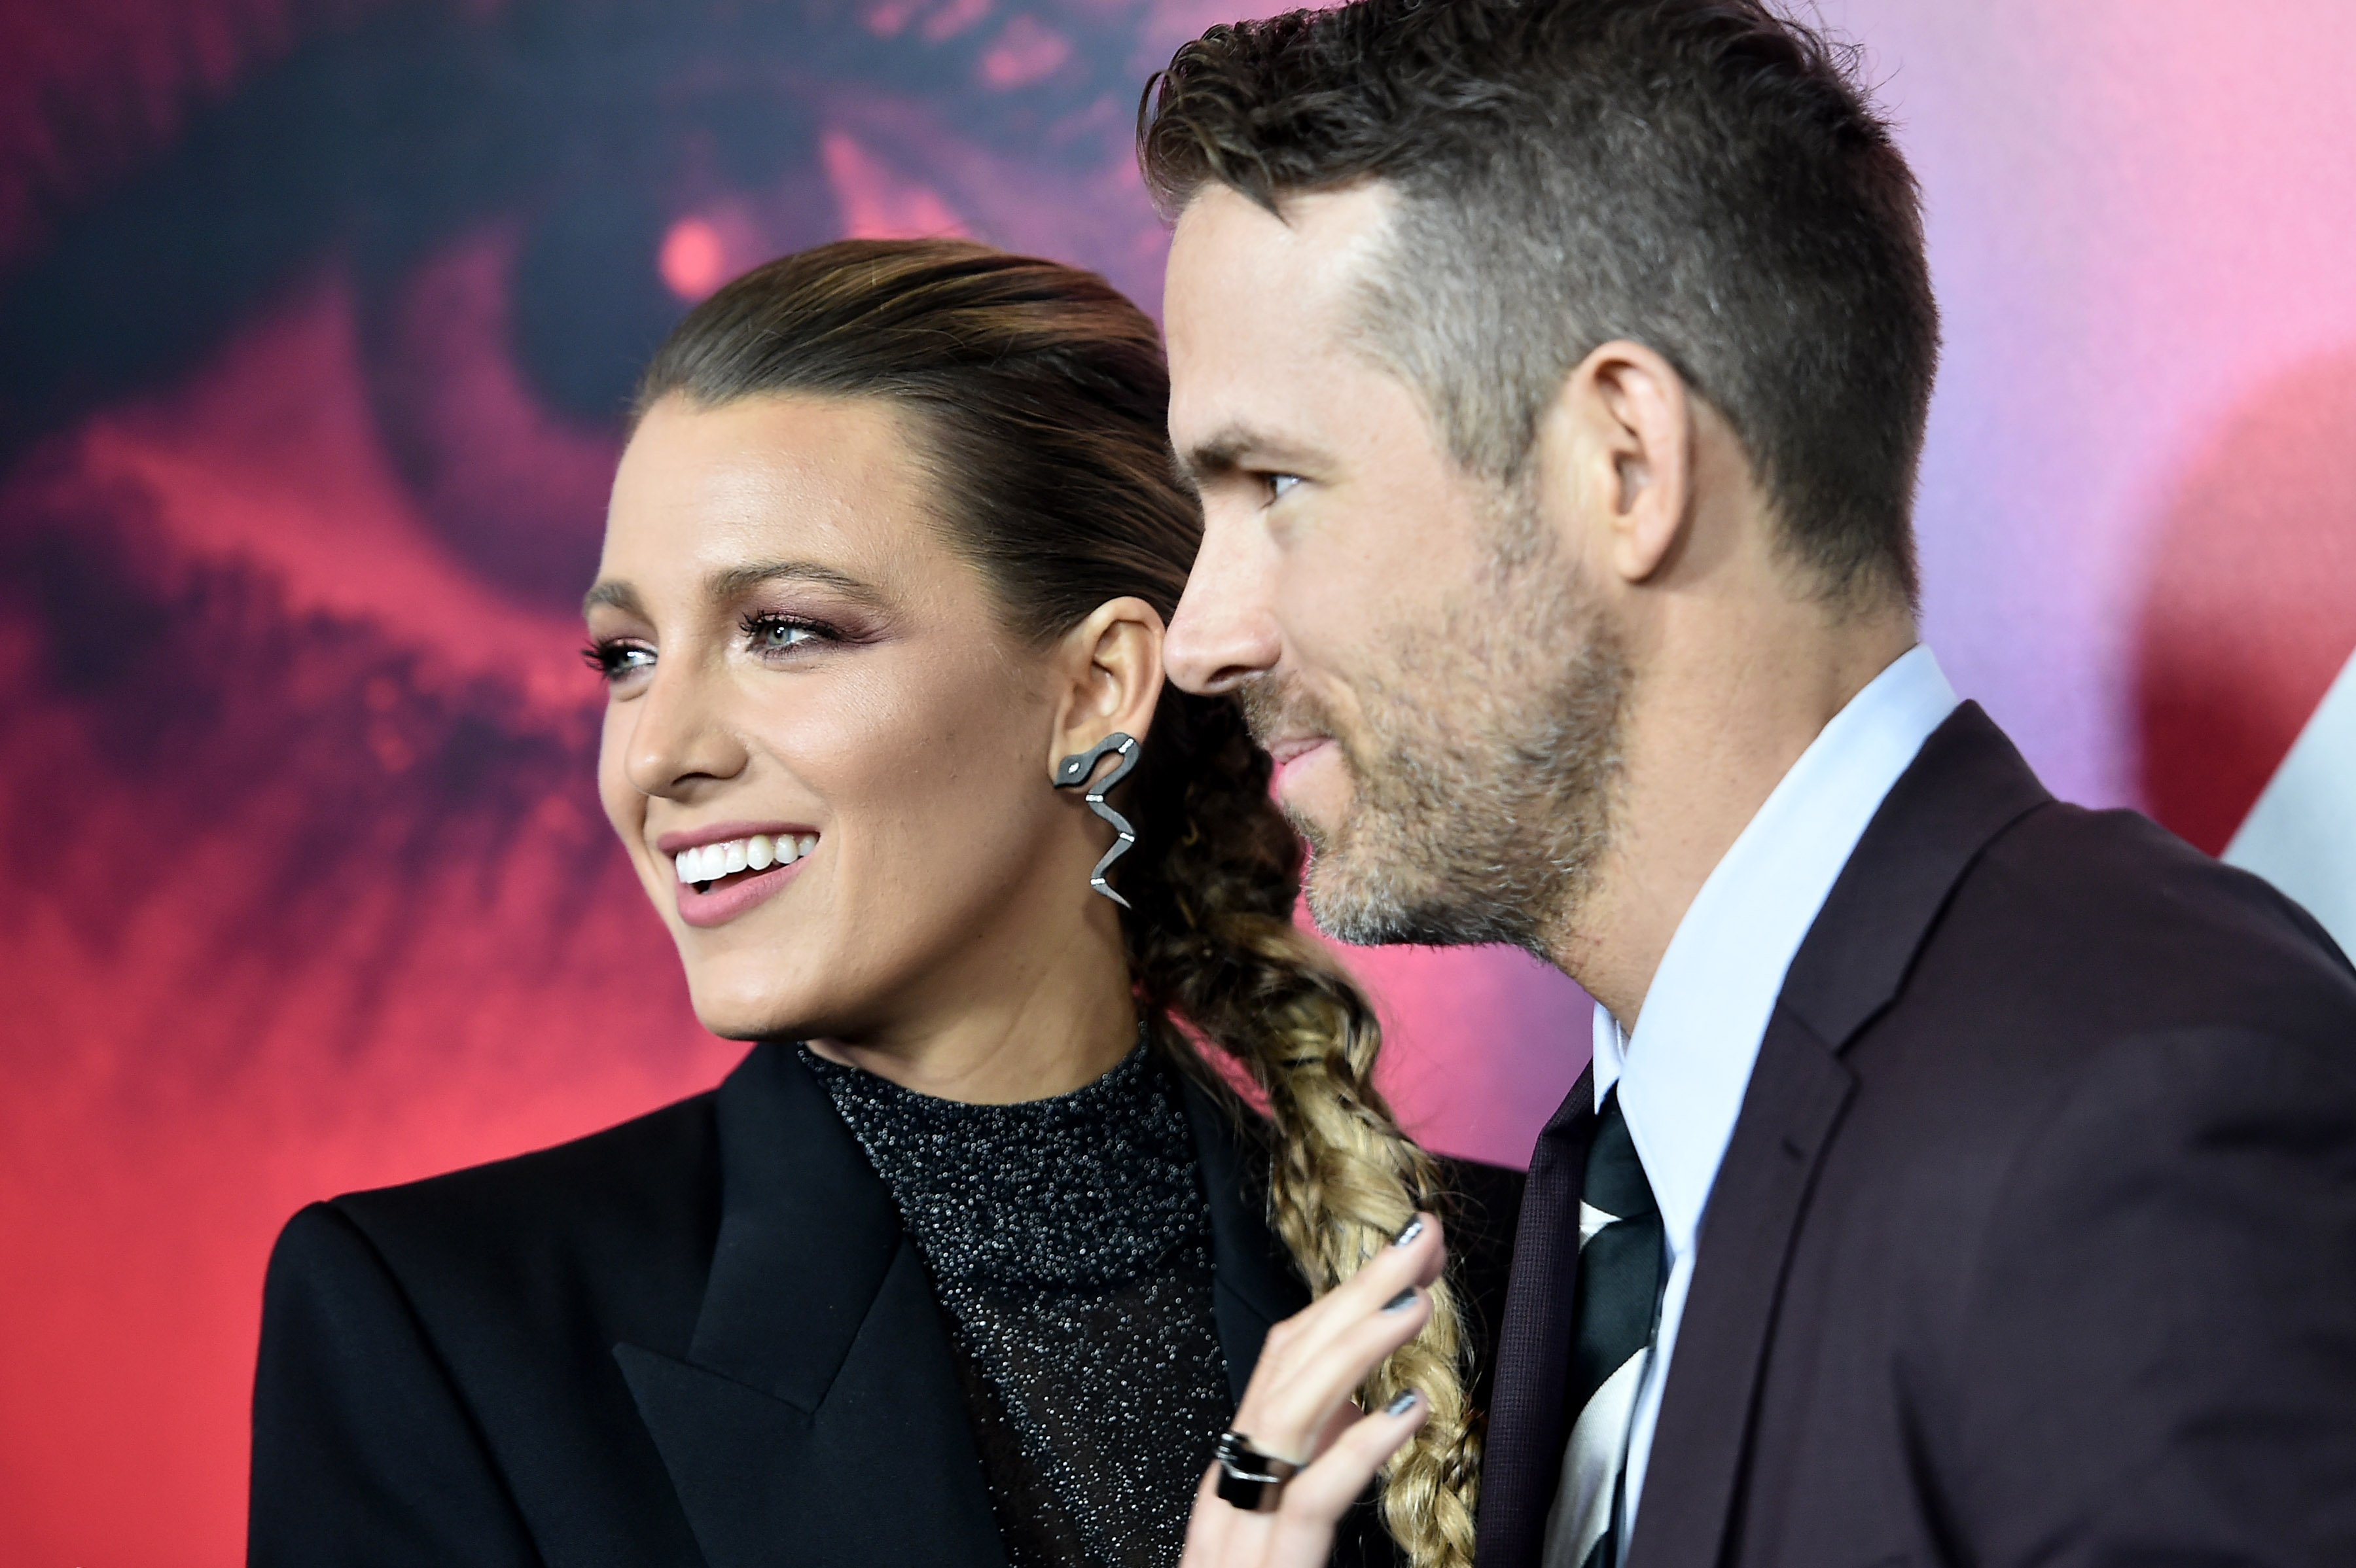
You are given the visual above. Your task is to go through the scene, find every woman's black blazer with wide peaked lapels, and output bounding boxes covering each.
[247,1045,1522,1568]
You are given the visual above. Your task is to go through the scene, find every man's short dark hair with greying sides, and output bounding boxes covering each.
[1138,0,1939,603]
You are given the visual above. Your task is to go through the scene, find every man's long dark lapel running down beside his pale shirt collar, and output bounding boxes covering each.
[1630,702,2052,1568]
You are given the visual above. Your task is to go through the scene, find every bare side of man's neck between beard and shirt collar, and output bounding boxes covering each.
[1548,615,1916,1031]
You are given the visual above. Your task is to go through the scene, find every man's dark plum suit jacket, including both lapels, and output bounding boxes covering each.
[1480,704,2356,1568]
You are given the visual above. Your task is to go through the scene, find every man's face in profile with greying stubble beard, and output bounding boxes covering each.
[1164,186,1626,951]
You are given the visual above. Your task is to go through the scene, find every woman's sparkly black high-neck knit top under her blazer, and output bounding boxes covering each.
[801,1045,1232,1568]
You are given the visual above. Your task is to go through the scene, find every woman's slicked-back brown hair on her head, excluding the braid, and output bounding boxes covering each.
[636,240,1202,638]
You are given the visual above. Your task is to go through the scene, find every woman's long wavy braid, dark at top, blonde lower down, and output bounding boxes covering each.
[1116,692,1480,1568]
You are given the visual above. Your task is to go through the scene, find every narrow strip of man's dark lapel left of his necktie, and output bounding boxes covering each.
[1475,1064,1595,1568]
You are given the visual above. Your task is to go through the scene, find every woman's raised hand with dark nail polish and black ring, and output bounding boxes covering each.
[1181,1215,1449,1568]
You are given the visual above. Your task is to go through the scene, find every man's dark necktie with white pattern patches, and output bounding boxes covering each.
[1543,1085,1666,1568]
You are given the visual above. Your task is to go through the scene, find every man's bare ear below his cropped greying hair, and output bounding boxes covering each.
[1539,339,1694,582]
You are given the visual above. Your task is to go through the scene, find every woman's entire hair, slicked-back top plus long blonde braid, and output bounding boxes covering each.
[636,240,1480,1568]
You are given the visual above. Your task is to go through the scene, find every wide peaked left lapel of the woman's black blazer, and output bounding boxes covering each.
[615,1045,1004,1568]
